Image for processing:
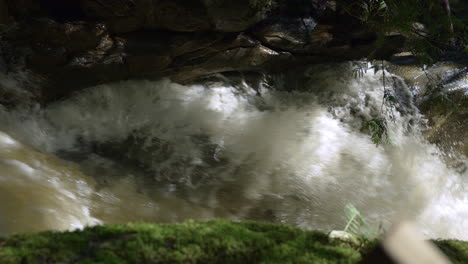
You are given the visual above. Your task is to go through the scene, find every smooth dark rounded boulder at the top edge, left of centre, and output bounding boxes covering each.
[81,0,272,33]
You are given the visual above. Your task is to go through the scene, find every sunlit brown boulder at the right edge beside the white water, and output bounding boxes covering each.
[414,66,468,170]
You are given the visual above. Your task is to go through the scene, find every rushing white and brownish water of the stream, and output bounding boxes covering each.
[0,64,468,239]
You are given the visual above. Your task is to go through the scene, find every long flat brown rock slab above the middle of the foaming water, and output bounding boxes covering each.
[119,32,290,82]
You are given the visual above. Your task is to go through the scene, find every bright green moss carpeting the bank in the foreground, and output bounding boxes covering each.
[0,220,468,264]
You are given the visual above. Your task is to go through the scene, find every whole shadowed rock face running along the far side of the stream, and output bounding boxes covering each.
[0,0,404,102]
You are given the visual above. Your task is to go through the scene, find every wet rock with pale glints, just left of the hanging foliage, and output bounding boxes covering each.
[252,13,405,60]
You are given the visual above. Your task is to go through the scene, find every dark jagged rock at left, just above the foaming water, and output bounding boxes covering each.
[28,30,129,102]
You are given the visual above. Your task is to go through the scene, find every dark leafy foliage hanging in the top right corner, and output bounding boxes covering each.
[337,0,467,64]
